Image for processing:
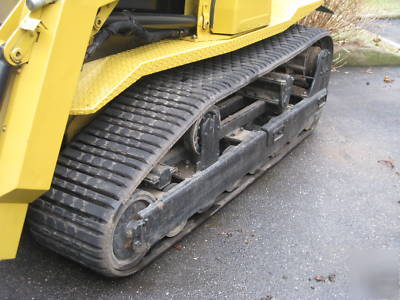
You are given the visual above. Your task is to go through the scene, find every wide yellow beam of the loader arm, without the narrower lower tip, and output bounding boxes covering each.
[0,0,115,203]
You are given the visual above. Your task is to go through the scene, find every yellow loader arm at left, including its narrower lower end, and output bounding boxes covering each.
[0,0,117,259]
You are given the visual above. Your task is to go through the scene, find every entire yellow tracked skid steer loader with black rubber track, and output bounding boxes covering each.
[0,0,333,277]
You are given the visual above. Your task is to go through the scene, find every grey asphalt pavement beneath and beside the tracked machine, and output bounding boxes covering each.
[0,47,400,299]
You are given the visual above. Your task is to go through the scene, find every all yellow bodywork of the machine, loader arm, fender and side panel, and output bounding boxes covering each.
[0,0,323,259]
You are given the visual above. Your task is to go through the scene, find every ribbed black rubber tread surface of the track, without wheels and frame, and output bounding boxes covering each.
[28,26,327,272]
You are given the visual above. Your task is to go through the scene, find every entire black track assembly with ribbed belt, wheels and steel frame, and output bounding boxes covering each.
[28,26,332,276]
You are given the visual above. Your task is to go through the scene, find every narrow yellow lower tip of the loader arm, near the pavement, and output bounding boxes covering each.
[0,203,28,260]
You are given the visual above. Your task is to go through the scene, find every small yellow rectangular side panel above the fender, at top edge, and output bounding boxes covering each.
[211,0,272,34]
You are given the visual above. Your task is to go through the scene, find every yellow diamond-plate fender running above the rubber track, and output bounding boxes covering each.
[71,0,323,115]
